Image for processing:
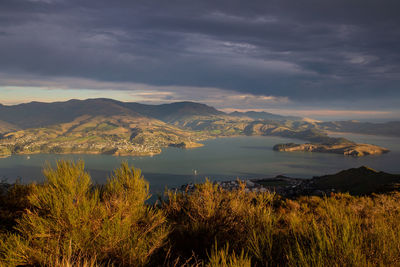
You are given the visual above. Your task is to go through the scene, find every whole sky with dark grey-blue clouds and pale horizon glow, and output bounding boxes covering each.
[0,0,400,120]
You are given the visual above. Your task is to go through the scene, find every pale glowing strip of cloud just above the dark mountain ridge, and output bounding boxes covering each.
[0,74,290,109]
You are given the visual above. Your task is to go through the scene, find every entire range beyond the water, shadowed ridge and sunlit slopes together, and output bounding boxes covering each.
[0,98,400,158]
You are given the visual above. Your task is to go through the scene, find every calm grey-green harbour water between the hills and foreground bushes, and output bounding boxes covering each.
[0,134,400,196]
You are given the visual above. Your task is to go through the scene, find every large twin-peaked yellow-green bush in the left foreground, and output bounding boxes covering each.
[0,161,168,266]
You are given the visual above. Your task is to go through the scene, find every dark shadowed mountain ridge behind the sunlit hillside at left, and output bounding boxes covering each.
[0,98,225,129]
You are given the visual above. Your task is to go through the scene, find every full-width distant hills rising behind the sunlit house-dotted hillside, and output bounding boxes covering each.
[0,98,400,142]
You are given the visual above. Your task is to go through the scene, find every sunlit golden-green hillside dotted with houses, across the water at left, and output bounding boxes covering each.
[0,115,204,156]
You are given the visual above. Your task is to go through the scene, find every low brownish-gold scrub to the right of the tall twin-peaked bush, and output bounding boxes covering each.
[163,182,400,266]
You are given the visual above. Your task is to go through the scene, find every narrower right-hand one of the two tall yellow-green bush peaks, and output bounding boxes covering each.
[97,163,168,266]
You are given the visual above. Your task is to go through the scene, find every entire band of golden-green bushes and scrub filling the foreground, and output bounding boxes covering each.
[0,161,400,266]
